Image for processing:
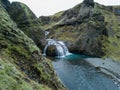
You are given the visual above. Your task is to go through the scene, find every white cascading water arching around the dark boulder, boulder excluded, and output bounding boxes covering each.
[44,39,70,58]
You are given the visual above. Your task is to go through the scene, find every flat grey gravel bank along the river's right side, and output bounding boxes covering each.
[85,58,120,88]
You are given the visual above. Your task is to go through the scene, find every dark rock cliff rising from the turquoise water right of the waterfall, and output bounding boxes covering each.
[71,21,107,57]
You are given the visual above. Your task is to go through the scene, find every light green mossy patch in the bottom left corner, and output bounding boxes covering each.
[0,57,51,90]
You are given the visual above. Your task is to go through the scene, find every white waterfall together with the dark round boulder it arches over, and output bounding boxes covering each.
[44,39,70,58]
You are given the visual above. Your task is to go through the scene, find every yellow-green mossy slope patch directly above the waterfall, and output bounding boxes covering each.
[49,25,78,41]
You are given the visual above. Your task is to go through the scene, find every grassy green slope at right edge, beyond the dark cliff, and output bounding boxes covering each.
[95,6,120,60]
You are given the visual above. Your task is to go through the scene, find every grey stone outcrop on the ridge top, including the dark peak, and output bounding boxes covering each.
[58,0,94,26]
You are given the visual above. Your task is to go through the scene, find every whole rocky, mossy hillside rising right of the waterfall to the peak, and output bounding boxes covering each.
[39,0,120,59]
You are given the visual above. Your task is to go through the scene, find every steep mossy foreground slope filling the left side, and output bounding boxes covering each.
[0,1,66,90]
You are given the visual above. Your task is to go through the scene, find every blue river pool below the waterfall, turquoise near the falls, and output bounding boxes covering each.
[52,54,120,90]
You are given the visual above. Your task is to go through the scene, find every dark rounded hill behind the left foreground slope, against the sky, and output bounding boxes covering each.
[7,2,45,49]
